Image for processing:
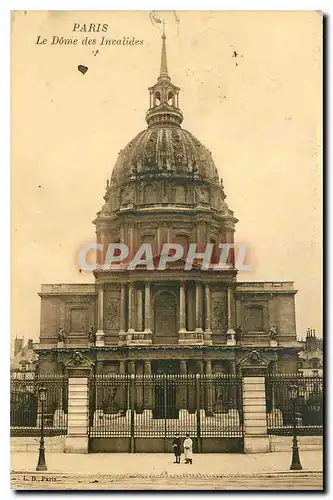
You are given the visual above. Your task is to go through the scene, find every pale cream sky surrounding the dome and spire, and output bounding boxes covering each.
[11,11,323,341]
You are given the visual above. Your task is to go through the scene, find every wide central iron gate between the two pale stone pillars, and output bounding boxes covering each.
[89,374,243,452]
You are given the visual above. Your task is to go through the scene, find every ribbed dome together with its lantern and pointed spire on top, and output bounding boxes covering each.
[110,34,219,188]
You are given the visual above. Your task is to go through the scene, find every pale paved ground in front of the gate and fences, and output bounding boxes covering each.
[11,451,322,490]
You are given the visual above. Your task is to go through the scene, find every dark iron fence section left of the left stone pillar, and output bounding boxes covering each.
[10,373,68,436]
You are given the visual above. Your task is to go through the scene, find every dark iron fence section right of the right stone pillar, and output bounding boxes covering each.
[266,374,323,435]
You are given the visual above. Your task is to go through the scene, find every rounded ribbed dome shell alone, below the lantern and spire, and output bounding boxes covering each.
[111,124,219,186]
